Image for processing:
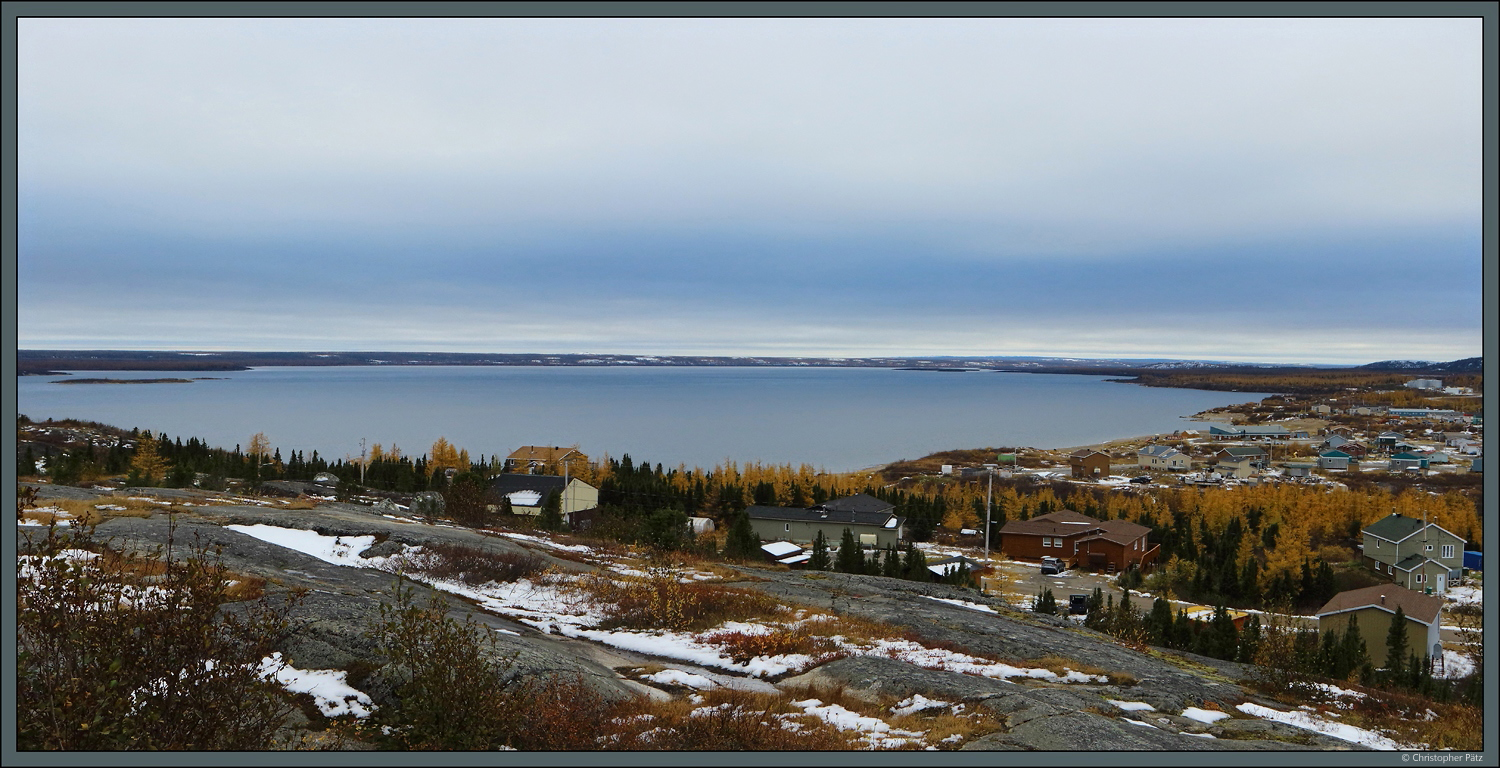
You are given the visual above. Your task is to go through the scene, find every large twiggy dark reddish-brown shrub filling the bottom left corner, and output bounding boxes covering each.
[15,513,297,750]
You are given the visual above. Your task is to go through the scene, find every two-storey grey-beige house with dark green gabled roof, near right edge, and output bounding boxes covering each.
[1364,513,1464,594]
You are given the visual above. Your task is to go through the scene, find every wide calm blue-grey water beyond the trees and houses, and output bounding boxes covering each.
[17,366,1266,471]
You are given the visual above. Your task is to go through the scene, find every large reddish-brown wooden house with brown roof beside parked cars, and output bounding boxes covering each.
[1001,510,1161,570]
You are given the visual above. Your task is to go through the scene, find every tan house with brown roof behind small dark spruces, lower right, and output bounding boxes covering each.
[1317,584,1443,668]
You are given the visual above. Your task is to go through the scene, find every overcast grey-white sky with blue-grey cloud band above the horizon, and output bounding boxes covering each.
[18,18,1482,363]
